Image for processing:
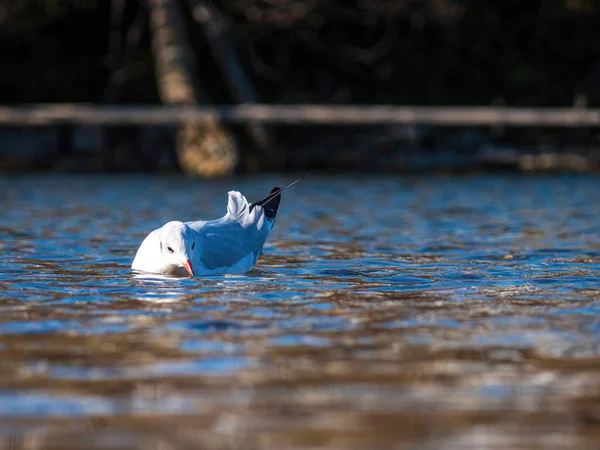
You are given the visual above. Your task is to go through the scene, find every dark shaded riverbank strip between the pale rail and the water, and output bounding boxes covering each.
[0,126,600,173]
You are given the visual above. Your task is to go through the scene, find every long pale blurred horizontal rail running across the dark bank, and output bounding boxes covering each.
[0,104,600,127]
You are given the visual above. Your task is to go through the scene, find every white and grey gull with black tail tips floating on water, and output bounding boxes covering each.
[131,176,304,277]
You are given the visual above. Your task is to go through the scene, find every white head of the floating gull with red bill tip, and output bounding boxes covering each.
[158,221,197,277]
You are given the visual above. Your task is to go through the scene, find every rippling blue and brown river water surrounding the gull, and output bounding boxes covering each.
[0,175,600,449]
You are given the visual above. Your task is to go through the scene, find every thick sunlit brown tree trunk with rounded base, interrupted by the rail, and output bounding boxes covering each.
[148,0,238,177]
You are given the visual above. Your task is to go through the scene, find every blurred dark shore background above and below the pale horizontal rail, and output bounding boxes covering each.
[0,0,600,176]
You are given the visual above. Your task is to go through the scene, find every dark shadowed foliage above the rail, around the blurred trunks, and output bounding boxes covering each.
[0,0,600,105]
